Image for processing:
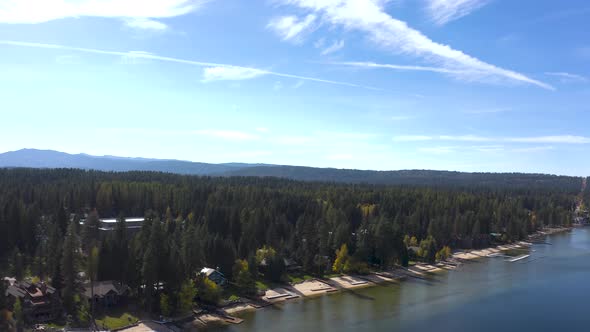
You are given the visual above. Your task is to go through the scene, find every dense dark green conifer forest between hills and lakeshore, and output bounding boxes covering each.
[0,169,582,320]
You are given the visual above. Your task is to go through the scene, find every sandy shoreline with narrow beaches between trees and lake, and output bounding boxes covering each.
[186,227,573,329]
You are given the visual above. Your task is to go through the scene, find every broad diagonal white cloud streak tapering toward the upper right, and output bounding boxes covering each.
[277,0,554,90]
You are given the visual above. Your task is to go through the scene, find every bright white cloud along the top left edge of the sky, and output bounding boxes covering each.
[0,0,209,23]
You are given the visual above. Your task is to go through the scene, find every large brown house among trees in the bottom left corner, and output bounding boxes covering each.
[5,281,62,322]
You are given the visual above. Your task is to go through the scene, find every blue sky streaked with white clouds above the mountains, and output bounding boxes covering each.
[0,0,590,176]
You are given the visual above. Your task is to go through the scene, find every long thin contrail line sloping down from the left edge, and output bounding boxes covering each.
[0,40,382,90]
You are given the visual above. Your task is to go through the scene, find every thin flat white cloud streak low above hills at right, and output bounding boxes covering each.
[393,135,590,144]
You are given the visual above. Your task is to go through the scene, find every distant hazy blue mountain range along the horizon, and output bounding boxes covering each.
[0,149,581,188]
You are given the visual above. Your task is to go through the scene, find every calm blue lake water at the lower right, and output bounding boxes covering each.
[214,228,590,332]
